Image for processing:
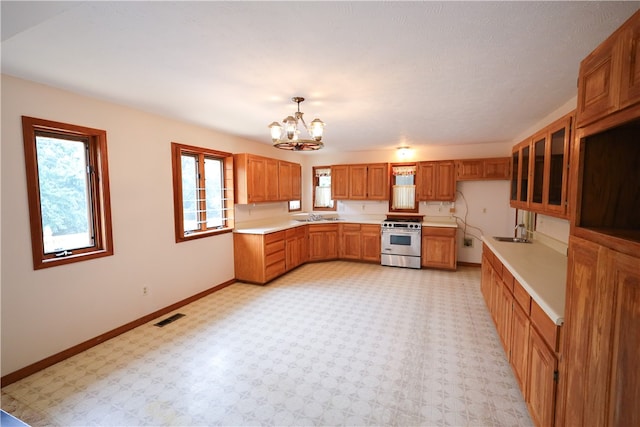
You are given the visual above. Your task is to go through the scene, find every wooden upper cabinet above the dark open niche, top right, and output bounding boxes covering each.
[577,11,640,127]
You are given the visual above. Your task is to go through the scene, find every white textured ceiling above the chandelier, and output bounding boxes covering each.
[1,1,640,151]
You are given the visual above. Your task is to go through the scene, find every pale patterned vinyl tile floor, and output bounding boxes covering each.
[2,261,532,427]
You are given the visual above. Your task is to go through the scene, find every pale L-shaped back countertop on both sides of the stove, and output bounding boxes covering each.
[233,214,458,234]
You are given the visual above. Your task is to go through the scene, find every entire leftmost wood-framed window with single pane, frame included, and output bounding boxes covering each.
[22,116,113,269]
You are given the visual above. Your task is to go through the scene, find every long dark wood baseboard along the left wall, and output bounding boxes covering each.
[0,279,236,387]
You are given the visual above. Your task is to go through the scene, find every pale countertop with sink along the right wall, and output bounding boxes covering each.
[482,236,567,325]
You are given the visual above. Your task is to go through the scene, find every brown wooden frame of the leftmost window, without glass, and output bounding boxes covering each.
[22,116,114,270]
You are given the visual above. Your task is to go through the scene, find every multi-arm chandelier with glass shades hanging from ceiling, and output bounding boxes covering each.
[269,96,324,151]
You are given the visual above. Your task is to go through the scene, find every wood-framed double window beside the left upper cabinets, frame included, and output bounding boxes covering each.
[171,142,234,242]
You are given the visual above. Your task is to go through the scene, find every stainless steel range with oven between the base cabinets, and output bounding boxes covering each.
[380,218,422,268]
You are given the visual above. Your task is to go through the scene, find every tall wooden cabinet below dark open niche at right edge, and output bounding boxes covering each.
[559,236,640,426]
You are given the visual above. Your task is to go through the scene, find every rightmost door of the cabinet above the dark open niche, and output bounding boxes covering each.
[620,14,640,112]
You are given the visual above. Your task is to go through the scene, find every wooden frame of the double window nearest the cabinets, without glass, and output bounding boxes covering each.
[171,142,235,243]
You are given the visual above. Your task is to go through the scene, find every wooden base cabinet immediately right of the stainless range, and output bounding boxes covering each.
[421,227,457,270]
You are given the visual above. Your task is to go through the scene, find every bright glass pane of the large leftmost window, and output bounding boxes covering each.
[36,135,94,254]
